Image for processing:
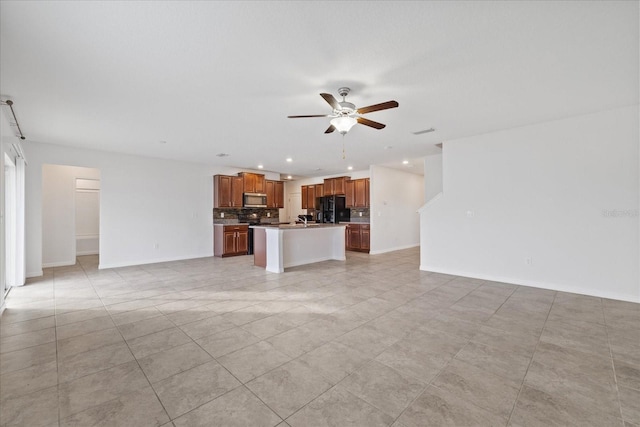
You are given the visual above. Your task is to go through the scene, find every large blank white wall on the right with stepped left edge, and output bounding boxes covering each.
[421,106,640,302]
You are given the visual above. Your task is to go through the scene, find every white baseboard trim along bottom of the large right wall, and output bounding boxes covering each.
[420,264,640,303]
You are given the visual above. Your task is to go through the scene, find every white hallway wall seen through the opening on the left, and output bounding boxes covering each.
[42,164,100,268]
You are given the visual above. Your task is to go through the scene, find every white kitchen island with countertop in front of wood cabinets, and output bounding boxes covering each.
[252,224,346,273]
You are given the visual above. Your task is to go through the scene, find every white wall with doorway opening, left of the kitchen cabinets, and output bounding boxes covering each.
[24,142,278,277]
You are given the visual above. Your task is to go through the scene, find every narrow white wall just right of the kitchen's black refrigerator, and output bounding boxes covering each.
[370,166,425,254]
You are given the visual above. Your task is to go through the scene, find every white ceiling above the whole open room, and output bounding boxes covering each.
[0,0,639,177]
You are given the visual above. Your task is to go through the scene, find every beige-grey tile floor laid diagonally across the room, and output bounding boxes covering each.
[0,249,640,427]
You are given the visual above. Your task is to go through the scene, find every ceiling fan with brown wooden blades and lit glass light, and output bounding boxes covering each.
[288,87,398,135]
